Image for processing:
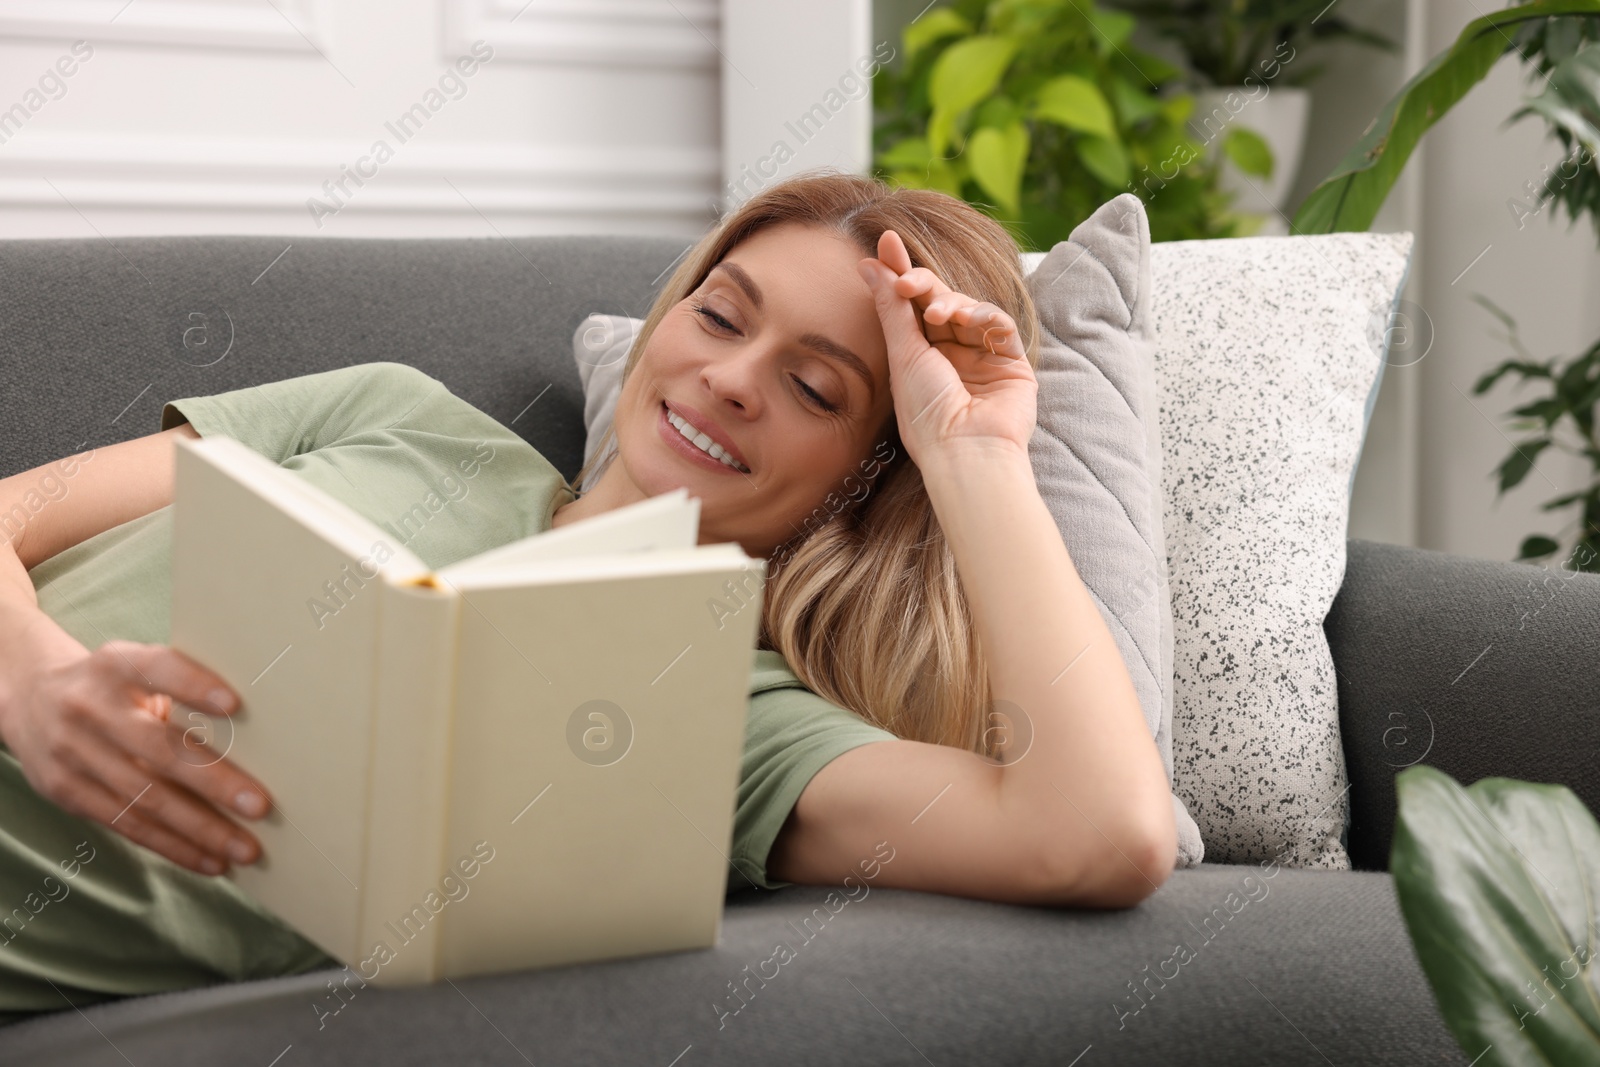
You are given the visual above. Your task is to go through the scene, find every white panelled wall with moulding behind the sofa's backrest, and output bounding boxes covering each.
[0,0,722,238]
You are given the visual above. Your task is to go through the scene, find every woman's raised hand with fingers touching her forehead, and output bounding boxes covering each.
[856,230,1038,467]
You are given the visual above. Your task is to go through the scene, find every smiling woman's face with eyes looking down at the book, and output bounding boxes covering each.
[614,222,894,557]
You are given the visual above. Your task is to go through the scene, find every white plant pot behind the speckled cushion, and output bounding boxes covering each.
[1189,82,1310,235]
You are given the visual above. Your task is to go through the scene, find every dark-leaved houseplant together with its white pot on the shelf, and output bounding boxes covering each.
[1115,0,1395,234]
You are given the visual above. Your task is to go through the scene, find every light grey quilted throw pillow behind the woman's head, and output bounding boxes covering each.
[573,194,1205,867]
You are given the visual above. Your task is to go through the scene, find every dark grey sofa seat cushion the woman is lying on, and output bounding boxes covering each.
[3,864,1464,1067]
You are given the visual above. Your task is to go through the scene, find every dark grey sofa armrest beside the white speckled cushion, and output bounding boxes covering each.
[1323,541,1600,870]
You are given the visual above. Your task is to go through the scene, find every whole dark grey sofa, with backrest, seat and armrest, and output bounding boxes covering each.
[0,237,1600,1067]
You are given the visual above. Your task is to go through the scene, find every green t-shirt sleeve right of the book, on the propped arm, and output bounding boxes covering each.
[728,651,896,891]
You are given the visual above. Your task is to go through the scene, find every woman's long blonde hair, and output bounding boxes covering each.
[576,170,1038,757]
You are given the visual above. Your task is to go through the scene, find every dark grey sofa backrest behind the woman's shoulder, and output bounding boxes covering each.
[0,237,690,478]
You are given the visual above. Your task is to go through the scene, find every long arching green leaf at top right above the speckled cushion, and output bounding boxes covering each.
[1290,0,1600,234]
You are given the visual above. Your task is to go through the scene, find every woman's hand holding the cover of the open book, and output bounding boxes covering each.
[0,619,270,875]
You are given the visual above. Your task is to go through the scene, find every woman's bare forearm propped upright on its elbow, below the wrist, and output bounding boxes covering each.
[923,448,1176,888]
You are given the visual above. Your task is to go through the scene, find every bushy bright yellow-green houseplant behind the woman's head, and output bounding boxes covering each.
[874,0,1237,250]
